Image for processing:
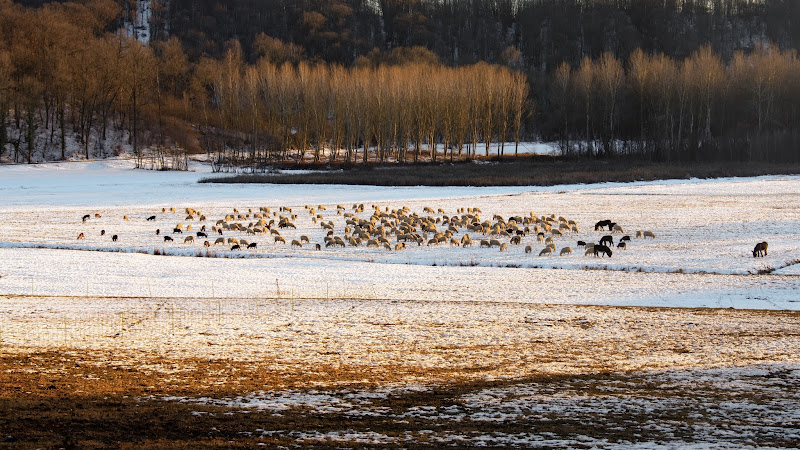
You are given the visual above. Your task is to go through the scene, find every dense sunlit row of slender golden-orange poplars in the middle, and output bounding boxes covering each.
[206,47,531,167]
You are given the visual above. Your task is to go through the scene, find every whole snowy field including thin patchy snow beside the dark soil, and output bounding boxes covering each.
[0,160,800,447]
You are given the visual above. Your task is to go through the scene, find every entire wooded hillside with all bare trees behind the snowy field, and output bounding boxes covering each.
[0,0,800,170]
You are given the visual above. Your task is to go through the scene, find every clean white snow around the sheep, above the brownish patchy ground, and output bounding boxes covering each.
[0,156,800,309]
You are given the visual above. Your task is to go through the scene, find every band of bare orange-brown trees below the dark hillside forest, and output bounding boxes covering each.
[0,0,800,168]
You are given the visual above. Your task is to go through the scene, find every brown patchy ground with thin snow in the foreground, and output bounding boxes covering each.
[0,299,800,448]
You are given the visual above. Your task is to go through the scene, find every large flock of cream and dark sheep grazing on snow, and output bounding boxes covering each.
[78,204,655,257]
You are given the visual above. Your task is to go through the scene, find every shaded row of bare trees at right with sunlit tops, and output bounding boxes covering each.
[541,43,800,161]
